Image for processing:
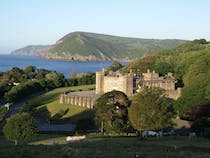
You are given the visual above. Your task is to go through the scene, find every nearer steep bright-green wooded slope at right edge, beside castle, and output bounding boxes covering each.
[174,53,210,117]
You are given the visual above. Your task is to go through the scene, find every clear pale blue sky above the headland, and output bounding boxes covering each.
[0,0,210,54]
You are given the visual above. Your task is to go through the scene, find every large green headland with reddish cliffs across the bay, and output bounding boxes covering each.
[39,32,185,61]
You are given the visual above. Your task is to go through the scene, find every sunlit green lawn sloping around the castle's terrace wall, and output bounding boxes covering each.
[23,85,95,123]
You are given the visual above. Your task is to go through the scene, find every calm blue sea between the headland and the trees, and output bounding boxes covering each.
[0,55,127,78]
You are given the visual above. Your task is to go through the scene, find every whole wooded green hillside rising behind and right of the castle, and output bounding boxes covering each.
[122,40,210,116]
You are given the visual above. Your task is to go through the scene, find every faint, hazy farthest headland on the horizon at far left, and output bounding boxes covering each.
[11,45,48,56]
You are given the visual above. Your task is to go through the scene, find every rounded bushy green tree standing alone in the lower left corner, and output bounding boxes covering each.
[3,113,38,145]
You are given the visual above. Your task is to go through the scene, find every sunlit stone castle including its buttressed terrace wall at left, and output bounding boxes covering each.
[60,69,181,108]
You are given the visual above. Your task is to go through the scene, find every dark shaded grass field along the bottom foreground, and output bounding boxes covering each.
[0,135,210,158]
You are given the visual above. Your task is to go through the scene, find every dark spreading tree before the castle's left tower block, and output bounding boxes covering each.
[94,90,129,133]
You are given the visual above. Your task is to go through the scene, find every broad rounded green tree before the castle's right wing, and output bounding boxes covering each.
[129,88,173,136]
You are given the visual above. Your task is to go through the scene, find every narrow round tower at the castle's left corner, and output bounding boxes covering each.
[96,70,104,95]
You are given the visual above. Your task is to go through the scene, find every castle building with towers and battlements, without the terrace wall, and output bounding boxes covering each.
[96,69,181,100]
